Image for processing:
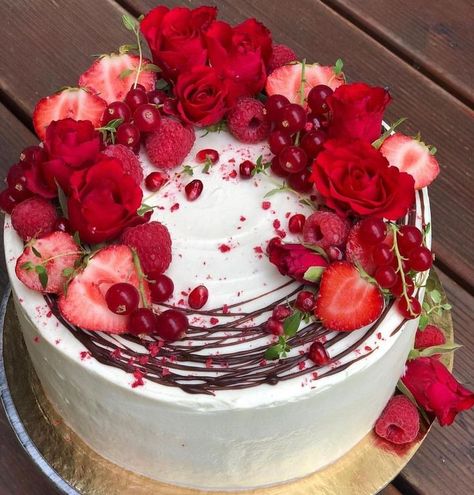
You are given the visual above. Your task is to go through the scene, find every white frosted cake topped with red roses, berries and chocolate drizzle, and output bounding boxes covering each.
[1,3,474,490]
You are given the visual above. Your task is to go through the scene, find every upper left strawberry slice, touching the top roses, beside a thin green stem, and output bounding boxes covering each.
[79,53,156,103]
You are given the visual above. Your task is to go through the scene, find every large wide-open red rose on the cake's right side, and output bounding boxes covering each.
[310,139,415,220]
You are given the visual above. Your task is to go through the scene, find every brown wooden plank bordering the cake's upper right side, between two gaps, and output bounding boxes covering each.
[123,0,474,287]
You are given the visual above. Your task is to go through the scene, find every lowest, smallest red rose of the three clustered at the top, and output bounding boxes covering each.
[175,66,227,127]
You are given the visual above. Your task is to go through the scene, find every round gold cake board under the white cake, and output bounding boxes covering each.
[0,270,453,495]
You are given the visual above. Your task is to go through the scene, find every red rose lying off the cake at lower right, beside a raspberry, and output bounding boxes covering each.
[402,357,474,426]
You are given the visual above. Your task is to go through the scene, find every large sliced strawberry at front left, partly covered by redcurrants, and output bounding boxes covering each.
[59,245,148,333]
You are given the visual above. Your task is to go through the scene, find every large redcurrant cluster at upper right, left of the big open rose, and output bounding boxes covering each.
[265,85,333,192]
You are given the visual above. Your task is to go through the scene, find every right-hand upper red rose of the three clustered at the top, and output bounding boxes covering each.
[205,19,272,106]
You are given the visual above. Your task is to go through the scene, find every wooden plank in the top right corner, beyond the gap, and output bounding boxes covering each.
[323,0,474,105]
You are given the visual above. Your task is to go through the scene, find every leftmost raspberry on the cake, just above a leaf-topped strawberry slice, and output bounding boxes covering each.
[12,196,58,241]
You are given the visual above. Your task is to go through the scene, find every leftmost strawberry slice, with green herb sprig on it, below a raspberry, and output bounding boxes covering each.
[15,232,81,294]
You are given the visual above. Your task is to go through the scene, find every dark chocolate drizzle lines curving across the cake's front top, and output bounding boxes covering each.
[45,192,425,395]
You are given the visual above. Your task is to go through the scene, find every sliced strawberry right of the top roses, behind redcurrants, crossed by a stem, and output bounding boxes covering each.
[265,62,344,103]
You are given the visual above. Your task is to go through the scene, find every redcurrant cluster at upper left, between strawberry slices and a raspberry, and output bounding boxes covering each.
[102,84,168,153]
